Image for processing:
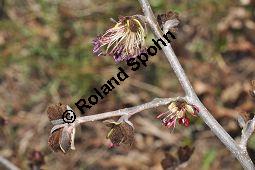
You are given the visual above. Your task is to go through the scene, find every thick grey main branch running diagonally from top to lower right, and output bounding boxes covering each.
[139,0,255,170]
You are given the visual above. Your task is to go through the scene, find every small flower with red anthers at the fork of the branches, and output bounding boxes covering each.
[157,101,199,128]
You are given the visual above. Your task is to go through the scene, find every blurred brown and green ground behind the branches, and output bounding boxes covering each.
[0,0,255,170]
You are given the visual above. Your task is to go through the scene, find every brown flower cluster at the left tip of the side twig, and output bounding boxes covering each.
[47,103,75,153]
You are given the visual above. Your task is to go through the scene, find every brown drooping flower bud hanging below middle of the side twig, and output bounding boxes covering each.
[104,120,134,147]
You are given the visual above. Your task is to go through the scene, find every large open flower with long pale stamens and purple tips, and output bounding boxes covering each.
[93,16,145,62]
